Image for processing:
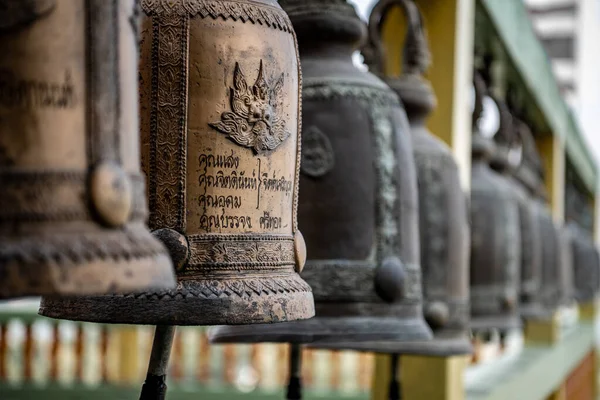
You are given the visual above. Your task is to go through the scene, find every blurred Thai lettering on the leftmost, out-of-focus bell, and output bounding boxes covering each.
[0,69,76,109]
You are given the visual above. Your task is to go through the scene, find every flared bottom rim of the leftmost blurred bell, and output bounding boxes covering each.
[0,223,176,299]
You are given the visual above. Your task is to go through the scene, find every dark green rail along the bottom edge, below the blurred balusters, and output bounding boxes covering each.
[0,384,368,400]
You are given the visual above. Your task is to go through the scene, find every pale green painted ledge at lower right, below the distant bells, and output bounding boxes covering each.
[467,323,595,400]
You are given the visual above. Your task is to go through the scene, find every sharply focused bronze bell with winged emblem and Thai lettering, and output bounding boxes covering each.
[40,0,314,325]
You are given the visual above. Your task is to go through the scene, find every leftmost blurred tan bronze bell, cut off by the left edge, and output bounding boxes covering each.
[0,0,175,299]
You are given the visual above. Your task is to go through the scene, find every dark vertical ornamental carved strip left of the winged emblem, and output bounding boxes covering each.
[148,15,189,231]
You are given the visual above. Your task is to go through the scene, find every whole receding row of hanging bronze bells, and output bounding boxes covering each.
[0,0,600,366]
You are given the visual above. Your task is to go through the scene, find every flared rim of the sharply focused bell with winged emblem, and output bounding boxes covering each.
[39,273,315,325]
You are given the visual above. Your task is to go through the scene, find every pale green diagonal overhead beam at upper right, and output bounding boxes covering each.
[479,0,598,193]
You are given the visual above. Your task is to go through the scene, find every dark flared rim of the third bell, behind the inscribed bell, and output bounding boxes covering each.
[209,316,432,344]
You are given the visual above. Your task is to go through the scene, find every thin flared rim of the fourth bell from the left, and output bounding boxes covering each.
[308,332,473,357]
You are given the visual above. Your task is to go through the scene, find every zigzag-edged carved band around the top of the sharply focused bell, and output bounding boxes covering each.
[141,0,293,32]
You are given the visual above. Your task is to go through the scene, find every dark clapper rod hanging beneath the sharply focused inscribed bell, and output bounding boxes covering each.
[140,325,175,400]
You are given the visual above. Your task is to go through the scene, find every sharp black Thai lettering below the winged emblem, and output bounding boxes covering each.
[198,149,294,232]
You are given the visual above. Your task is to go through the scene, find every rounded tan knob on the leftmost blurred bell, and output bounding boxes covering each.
[90,162,133,227]
